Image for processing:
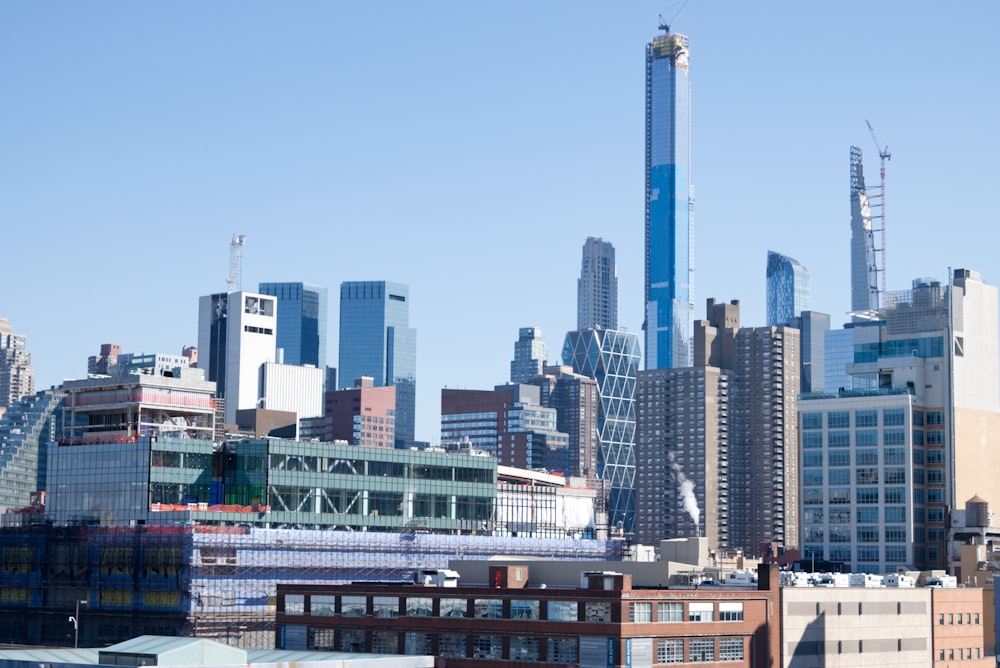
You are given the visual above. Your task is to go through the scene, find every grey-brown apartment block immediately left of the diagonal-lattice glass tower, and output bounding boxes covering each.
[528,366,600,480]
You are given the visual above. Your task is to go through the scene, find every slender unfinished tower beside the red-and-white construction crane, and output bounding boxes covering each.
[851,146,879,313]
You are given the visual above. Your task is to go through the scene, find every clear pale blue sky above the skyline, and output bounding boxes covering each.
[0,0,1000,442]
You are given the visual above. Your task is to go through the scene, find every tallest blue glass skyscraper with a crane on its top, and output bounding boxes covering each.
[644,30,694,369]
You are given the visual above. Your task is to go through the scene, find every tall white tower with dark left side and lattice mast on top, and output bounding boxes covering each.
[198,292,278,424]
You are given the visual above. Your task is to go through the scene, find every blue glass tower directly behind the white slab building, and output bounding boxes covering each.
[258,283,334,368]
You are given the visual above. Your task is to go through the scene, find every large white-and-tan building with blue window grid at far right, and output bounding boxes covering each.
[799,269,1000,573]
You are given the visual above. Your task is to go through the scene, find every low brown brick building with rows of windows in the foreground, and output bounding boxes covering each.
[276,562,779,668]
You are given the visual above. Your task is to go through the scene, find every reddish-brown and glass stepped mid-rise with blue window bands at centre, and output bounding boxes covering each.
[441,383,572,475]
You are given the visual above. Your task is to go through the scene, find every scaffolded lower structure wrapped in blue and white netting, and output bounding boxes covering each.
[0,524,622,648]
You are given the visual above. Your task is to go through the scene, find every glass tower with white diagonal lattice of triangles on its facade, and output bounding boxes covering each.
[562,329,639,532]
